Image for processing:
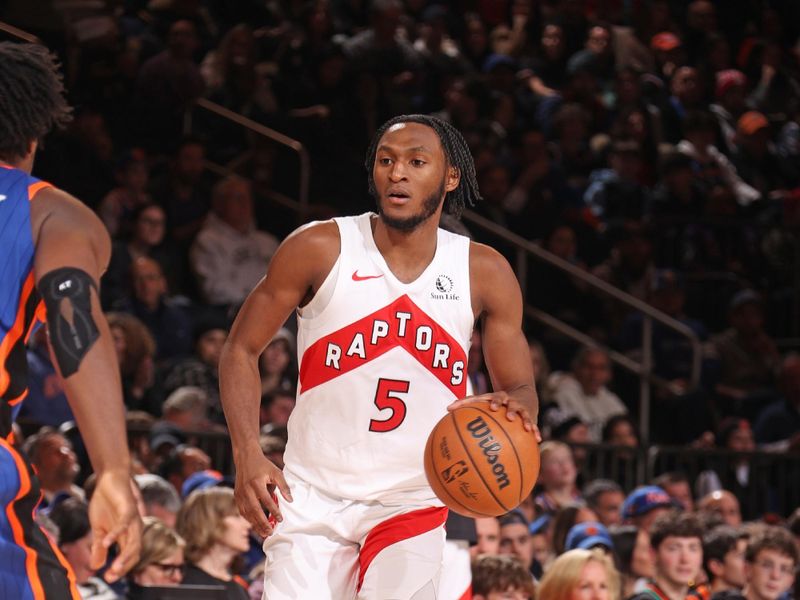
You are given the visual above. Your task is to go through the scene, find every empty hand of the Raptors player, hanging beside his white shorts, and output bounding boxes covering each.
[234,453,292,537]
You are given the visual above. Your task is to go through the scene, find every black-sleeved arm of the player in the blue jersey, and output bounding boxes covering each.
[31,189,141,580]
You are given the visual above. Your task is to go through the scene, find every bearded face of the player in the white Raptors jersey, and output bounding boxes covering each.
[372,123,458,231]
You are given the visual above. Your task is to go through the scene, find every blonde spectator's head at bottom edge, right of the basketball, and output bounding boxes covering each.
[539,549,619,600]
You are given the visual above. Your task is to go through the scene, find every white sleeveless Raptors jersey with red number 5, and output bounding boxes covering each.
[285,213,474,505]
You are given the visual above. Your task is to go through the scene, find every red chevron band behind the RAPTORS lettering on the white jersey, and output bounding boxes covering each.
[300,294,467,398]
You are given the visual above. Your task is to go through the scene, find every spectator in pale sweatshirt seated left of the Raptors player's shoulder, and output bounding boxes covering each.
[190,177,278,307]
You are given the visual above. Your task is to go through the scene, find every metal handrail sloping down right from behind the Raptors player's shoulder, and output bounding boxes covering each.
[463,210,703,444]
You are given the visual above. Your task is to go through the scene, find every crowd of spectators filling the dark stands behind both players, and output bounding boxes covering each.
[0,0,800,600]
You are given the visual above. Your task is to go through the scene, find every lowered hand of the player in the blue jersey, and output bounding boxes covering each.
[89,471,142,583]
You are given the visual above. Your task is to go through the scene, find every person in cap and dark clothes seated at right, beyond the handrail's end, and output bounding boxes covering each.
[711,289,781,417]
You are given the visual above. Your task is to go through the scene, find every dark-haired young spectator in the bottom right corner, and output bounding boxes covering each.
[714,527,798,600]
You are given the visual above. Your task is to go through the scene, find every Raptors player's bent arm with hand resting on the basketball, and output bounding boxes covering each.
[448,243,539,435]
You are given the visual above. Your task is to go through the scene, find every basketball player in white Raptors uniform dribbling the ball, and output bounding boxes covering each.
[220,115,538,600]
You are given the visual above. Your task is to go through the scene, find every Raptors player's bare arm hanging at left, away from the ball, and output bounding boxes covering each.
[220,222,339,536]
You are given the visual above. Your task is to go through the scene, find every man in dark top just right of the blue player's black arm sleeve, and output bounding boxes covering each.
[114,256,192,363]
